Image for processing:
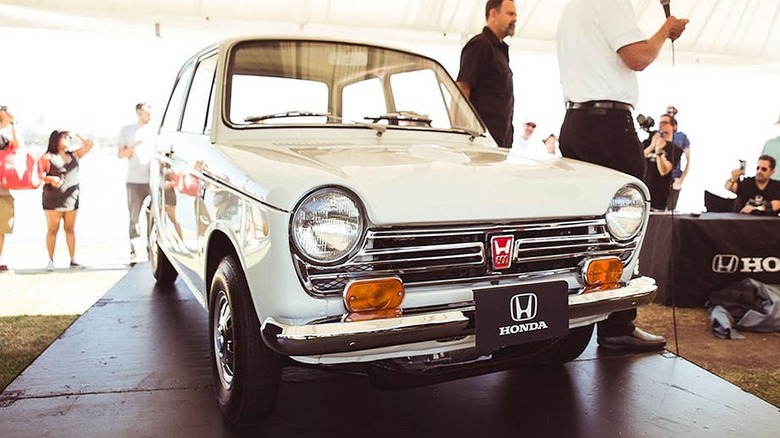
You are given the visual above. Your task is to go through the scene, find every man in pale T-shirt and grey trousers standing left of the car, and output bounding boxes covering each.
[117,102,155,262]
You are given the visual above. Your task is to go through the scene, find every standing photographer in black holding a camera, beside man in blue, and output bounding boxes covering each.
[644,114,682,211]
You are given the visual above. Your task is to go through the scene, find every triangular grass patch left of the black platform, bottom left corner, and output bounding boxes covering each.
[0,315,79,390]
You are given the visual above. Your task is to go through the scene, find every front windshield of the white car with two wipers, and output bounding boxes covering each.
[225,40,484,134]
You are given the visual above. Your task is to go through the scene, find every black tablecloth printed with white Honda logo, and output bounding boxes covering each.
[639,213,780,307]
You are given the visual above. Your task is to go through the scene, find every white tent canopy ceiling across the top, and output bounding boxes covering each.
[0,0,780,71]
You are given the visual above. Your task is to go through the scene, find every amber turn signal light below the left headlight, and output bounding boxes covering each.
[344,277,406,318]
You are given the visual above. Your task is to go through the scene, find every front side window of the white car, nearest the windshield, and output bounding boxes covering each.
[181,54,217,134]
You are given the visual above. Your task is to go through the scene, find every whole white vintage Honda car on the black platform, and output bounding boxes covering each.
[149,38,656,423]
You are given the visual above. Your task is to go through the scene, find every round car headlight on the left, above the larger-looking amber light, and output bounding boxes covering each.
[291,187,364,263]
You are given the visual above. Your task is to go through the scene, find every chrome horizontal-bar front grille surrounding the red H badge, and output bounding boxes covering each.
[296,218,637,295]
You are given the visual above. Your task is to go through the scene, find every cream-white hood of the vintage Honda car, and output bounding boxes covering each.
[218,140,646,224]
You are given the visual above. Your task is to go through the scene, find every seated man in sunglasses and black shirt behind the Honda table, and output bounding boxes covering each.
[725,155,780,214]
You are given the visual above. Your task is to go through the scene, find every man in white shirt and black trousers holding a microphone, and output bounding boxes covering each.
[558,0,688,350]
